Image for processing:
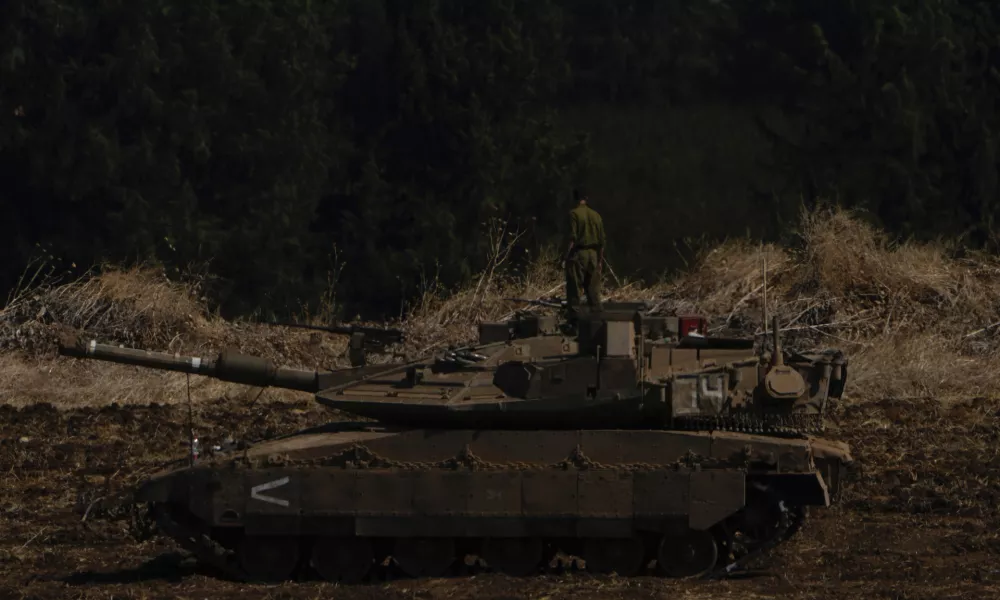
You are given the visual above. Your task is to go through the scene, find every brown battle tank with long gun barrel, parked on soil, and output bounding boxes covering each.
[54,303,852,583]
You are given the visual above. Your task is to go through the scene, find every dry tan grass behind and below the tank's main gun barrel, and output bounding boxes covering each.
[0,267,372,408]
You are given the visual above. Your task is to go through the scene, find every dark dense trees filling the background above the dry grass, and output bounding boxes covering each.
[0,0,1000,316]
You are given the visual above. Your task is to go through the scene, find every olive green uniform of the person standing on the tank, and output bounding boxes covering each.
[566,204,607,316]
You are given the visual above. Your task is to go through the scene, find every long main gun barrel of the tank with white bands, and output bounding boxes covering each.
[59,336,319,393]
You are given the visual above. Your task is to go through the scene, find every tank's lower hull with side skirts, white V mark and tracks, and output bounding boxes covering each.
[131,427,851,583]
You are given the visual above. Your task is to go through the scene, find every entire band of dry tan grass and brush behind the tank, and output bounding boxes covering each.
[0,209,1000,405]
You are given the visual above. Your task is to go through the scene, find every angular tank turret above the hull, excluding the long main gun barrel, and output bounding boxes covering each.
[316,305,846,435]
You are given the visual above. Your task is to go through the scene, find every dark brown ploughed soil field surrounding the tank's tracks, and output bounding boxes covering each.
[0,394,1000,599]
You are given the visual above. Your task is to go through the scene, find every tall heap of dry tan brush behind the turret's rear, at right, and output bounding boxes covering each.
[668,210,1000,402]
